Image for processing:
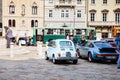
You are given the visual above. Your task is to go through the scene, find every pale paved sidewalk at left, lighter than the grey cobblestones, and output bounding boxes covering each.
[0,38,45,60]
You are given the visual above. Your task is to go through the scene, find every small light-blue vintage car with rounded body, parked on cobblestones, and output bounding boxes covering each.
[45,39,78,64]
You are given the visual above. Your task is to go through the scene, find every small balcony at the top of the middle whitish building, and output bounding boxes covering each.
[55,1,75,8]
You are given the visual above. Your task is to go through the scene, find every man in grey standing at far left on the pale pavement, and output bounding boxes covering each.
[4,26,13,48]
